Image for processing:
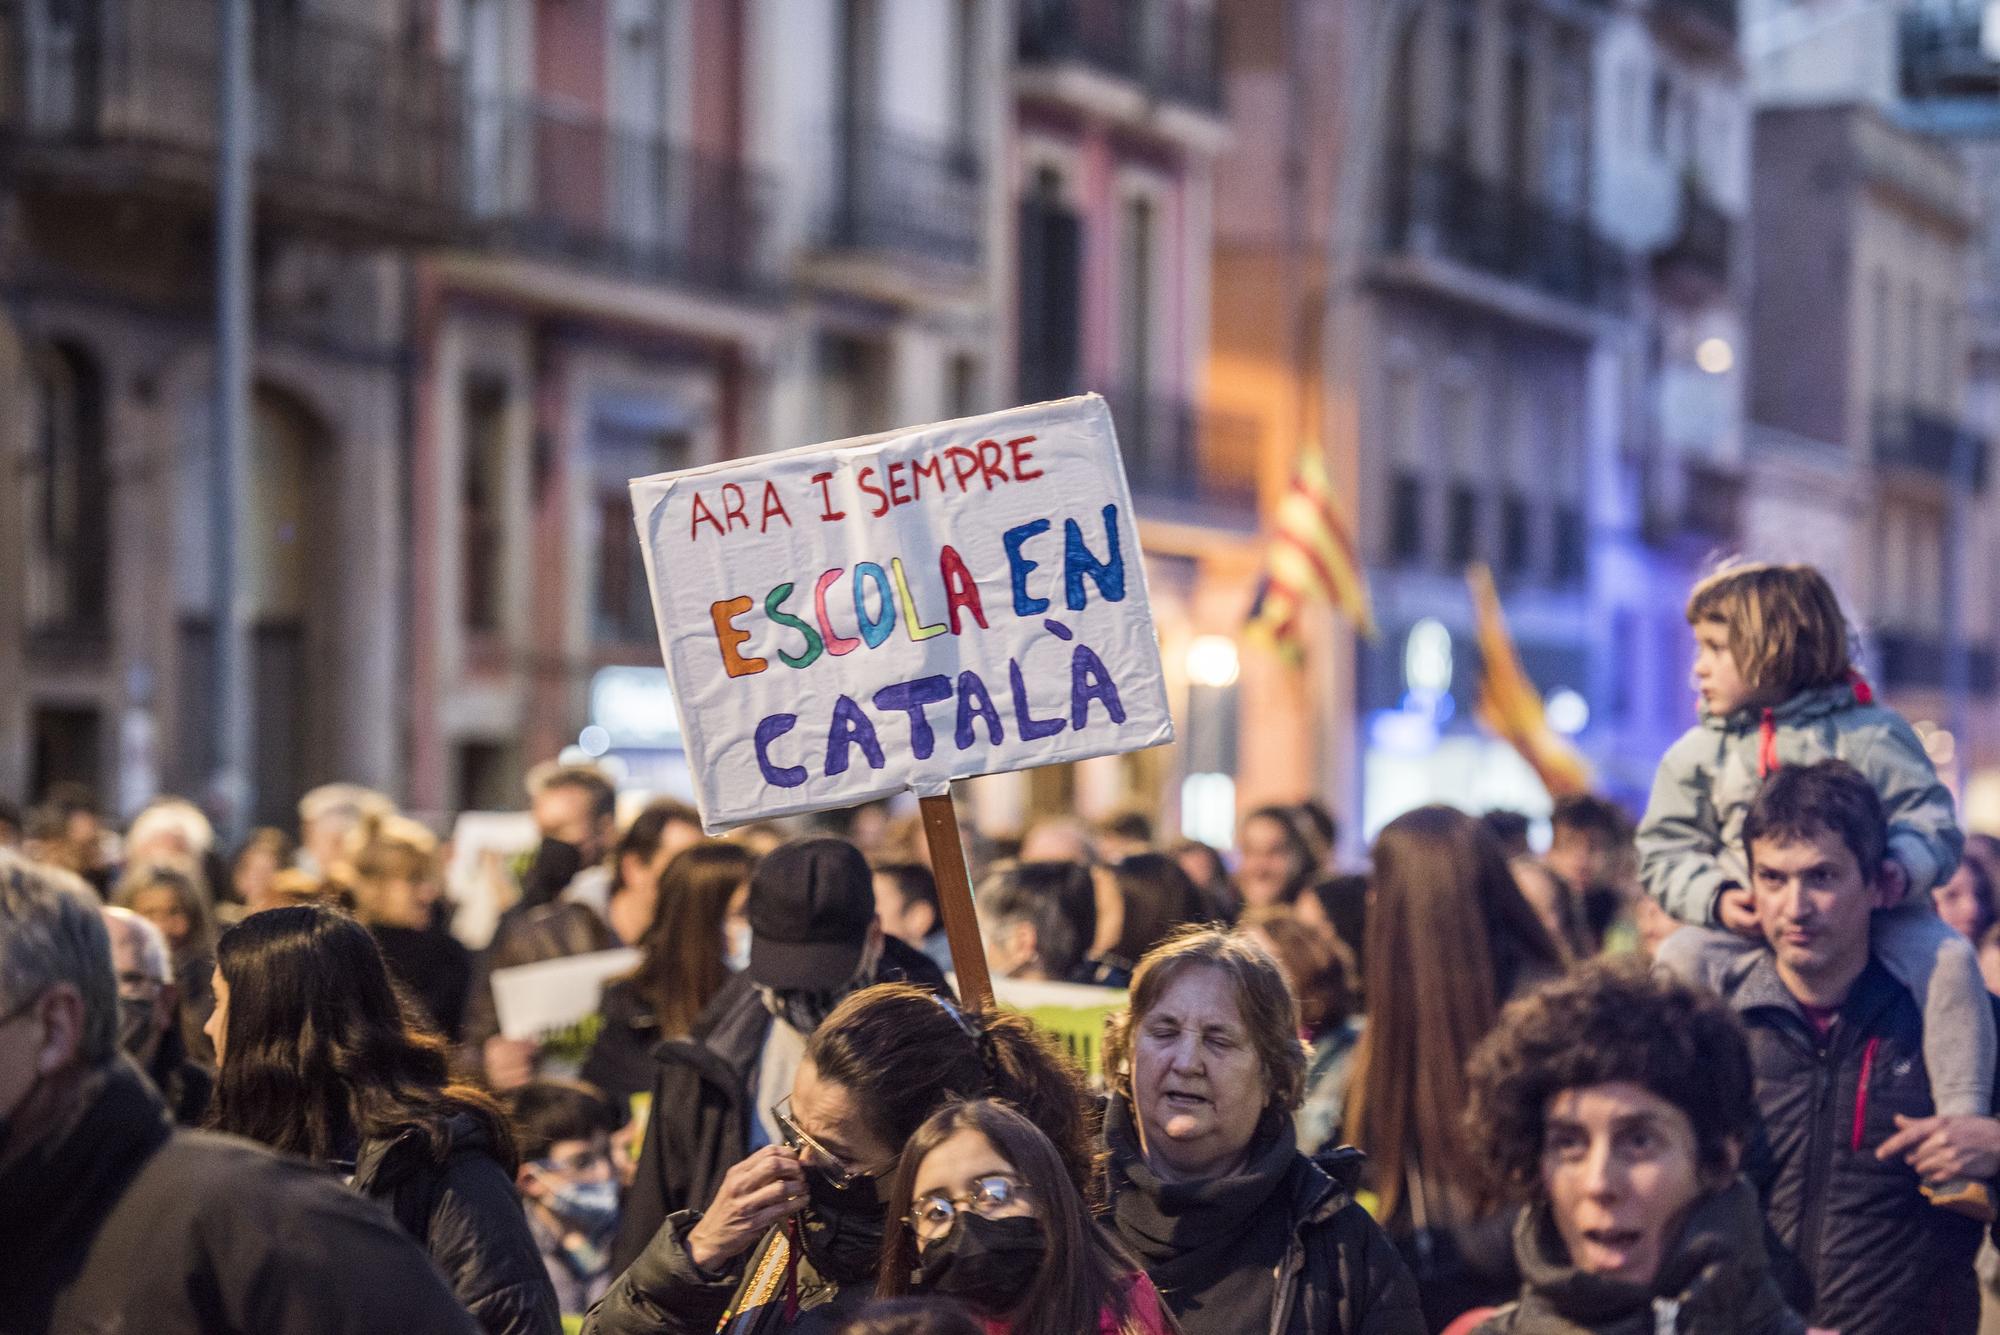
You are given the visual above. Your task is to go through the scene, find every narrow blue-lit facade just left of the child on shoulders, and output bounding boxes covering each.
[1588,0,1752,805]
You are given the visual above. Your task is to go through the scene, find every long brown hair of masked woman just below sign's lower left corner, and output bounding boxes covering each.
[626,839,756,1037]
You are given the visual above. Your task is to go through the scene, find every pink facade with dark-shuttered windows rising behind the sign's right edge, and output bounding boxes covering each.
[1000,0,1232,833]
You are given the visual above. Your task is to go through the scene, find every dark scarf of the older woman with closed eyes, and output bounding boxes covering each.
[1104,1097,1302,1335]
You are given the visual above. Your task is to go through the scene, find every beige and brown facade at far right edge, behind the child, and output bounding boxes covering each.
[1744,0,2000,787]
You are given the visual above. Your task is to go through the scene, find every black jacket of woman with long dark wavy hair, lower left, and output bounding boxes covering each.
[354,1113,562,1335]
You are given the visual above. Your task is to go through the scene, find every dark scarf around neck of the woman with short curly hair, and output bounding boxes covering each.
[1504,1177,1804,1335]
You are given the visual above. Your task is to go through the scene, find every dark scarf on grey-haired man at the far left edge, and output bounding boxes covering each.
[0,1057,174,1329]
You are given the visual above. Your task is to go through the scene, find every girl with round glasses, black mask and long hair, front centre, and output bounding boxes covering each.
[880,1099,1180,1335]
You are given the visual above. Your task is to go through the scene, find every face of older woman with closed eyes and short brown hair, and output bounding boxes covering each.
[1132,967,1270,1181]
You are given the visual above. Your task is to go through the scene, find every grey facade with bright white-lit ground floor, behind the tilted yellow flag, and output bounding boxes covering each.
[1356,0,1630,831]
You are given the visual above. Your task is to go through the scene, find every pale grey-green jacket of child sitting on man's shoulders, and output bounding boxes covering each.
[1638,681,1964,927]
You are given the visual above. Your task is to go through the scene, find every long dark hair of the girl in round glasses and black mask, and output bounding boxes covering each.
[876,1099,1140,1335]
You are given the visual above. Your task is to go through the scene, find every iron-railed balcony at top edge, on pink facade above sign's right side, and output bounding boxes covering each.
[1016,0,1224,114]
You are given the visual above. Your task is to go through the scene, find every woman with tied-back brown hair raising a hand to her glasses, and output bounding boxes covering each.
[584,983,1090,1335]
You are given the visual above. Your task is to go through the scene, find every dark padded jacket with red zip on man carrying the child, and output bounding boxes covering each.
[1722,951,1980,1335]
